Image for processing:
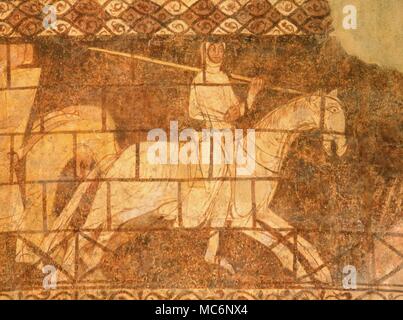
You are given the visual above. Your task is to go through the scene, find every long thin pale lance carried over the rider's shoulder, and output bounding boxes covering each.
[88,47,303,95]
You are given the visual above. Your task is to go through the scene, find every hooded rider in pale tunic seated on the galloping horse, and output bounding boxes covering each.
[189,42,263,273]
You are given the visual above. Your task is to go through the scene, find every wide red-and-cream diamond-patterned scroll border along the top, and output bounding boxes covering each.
[0,0,332,38]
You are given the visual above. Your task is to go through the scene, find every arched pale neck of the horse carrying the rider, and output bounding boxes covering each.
[256,99,317,176]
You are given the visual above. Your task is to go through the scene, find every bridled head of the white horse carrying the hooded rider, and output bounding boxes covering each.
[313,90,347,157]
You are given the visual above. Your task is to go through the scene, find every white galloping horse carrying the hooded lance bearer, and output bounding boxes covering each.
[18,92,346,283]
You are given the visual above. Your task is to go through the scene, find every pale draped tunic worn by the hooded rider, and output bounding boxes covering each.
[183,64,245,227]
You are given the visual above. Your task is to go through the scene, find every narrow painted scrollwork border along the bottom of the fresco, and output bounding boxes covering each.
[0,288,403,300]
